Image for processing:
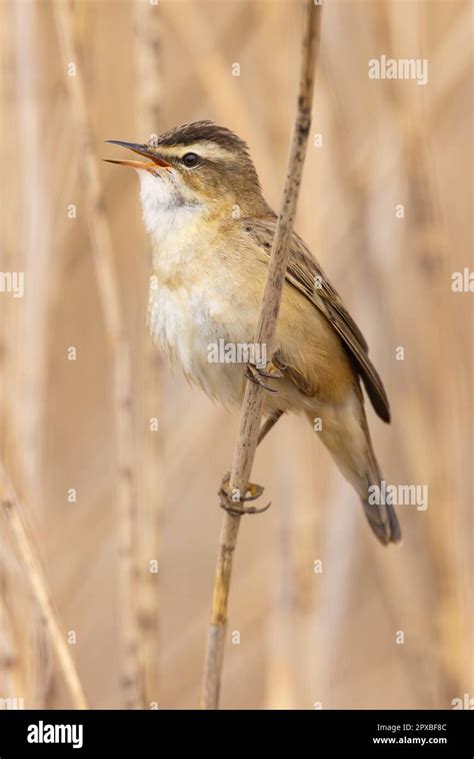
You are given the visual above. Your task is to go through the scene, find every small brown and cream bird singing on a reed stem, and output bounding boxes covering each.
[104,120,401,545]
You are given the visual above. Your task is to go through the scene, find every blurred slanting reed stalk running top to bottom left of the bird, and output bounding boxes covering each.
[54,0,141,709]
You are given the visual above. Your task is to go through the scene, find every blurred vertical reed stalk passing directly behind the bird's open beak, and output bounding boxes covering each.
[135,3,163,706]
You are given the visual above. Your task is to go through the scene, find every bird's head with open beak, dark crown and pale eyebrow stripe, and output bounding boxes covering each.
[106,121,268,231]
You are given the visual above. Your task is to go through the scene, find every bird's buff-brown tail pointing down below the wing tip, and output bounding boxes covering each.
[308,403,401,545]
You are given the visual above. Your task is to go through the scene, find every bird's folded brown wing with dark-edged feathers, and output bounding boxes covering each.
[252,220,390,422]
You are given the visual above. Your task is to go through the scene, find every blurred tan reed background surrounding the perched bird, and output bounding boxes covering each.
[0,0,474,709]
